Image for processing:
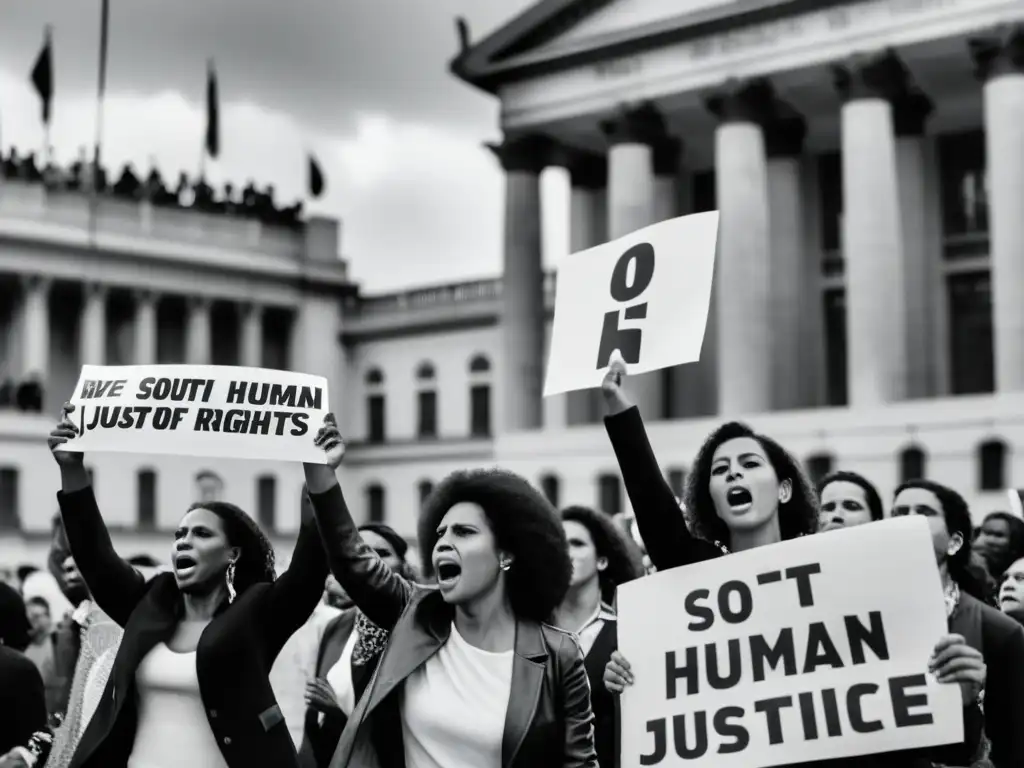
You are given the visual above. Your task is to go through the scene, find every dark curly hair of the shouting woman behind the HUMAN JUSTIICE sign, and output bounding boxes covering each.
[683,421,818,545]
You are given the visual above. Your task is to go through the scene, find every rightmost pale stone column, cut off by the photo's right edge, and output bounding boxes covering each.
[972,25,1024,392]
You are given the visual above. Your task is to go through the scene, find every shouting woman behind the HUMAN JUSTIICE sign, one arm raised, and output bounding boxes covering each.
[602,361,1001,768]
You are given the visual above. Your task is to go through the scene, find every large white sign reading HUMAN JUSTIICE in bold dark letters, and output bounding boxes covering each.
[618,516,964,768]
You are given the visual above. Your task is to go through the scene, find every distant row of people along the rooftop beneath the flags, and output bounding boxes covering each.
[0,148,302,228]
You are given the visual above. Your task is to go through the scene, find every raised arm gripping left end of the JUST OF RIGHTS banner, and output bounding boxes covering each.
[47,403,146,627]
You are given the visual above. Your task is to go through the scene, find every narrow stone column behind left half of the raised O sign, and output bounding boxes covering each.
[565,153,608,427]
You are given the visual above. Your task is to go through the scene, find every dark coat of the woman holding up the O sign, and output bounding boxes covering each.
[604,407,987,768]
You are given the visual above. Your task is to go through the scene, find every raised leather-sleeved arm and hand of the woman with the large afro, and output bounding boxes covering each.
[304,415,416,630]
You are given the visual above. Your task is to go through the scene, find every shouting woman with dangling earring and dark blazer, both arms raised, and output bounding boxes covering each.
[48,403,328,768]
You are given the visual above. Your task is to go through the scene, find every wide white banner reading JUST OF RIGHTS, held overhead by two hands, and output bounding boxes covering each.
[56,366,329,464]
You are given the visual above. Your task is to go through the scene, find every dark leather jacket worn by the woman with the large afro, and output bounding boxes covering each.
[310,486,597,768]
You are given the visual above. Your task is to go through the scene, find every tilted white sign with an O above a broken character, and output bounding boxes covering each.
[544,211,718,397]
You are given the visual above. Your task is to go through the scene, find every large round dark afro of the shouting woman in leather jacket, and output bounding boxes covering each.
[419,469,572,622]
